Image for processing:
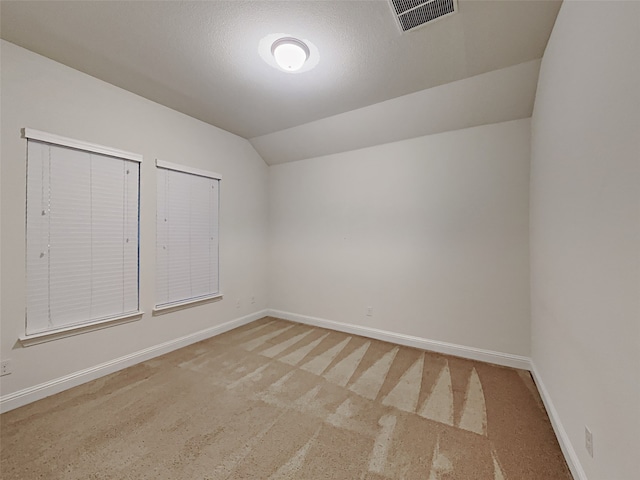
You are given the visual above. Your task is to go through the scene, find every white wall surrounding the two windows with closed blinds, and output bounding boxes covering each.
[0,41,268,402]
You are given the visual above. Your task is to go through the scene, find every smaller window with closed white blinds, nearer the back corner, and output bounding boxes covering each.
[156,161,221,310]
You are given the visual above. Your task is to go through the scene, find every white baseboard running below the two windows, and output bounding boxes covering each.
[0,310,268,413]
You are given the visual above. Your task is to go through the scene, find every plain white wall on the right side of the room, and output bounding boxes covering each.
[531,1,640,480]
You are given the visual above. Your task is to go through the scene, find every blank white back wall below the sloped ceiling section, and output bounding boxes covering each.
[269,119,530,356]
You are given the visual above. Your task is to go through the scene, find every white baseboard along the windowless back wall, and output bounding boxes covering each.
[268,310,531,370]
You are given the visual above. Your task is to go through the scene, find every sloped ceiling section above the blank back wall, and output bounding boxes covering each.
[250,60,540,165]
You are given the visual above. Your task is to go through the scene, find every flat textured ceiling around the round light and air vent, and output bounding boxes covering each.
[0,0,560,142]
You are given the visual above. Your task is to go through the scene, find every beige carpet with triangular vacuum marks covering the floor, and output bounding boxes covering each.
[0,318,571,480]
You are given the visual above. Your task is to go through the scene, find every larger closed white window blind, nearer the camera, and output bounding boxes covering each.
[26,131,140,335]
